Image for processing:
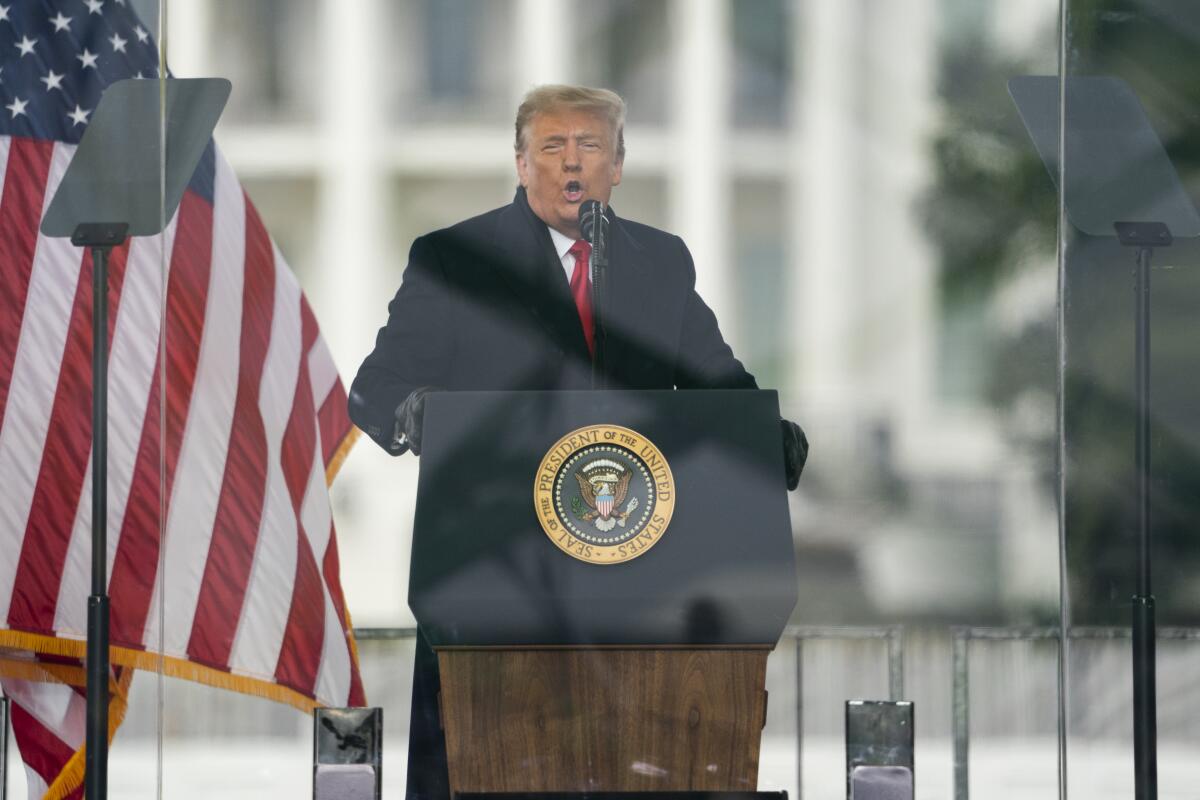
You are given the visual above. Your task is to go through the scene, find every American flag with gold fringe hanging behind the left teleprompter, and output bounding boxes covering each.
[0,0,364,796]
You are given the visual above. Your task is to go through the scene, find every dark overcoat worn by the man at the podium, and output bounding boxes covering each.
[349,188,757,800]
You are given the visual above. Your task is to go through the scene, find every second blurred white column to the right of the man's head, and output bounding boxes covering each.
[786,0,864,417]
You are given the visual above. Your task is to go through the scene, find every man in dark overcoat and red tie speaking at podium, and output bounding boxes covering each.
[349,85,808,799]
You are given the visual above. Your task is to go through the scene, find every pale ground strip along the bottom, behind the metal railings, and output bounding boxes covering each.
[8,738,1200,800]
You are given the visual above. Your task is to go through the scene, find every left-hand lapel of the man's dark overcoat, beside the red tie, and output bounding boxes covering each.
[496,188,588,359]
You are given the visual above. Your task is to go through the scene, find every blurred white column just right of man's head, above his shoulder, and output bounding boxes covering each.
[668,0,737,331]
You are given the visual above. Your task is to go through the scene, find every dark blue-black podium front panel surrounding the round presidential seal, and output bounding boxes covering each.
[409,391,796,646]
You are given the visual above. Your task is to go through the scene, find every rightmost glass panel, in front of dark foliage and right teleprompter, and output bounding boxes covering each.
[1061,0,1200,796]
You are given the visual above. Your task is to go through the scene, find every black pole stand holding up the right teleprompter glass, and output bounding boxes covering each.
[1114,222,1174,800]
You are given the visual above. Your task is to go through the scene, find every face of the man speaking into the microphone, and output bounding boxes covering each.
[517,110,622,239]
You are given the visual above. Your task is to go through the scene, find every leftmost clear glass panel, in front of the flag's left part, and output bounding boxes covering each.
[0,0,168,798]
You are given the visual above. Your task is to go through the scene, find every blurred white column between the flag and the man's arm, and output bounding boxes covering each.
[308,0,416,625]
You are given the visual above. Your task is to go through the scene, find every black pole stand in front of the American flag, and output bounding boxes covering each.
[71,223,128,800]
